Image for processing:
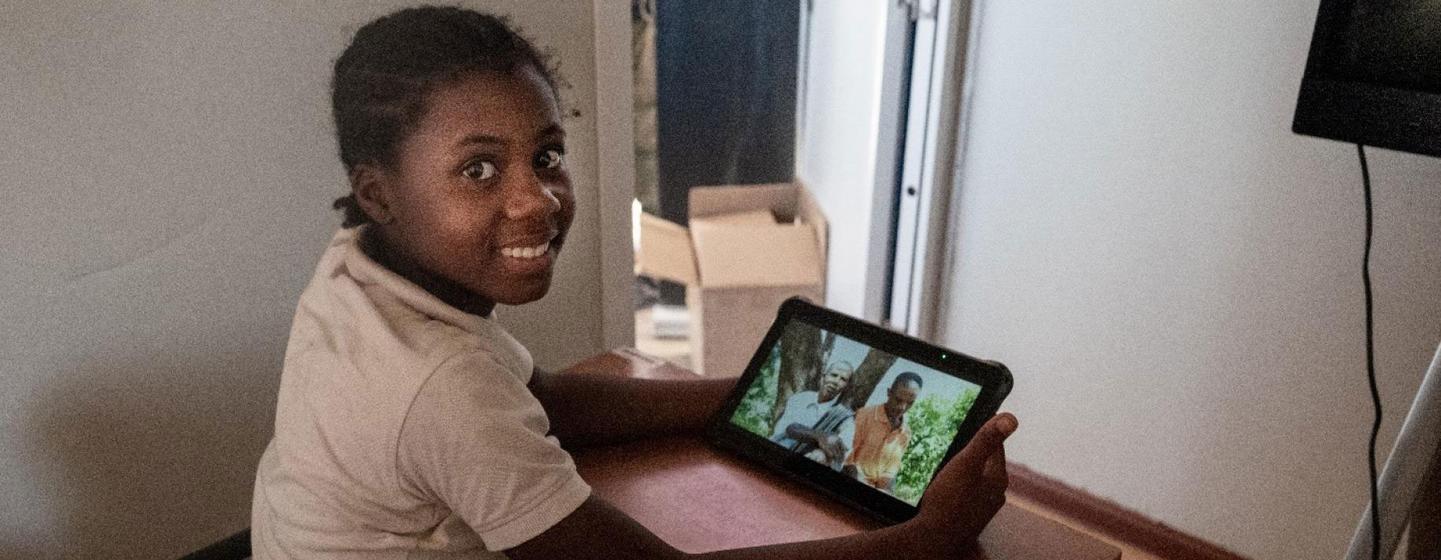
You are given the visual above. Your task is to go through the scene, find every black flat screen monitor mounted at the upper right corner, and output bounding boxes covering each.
[1291,0,1441,155]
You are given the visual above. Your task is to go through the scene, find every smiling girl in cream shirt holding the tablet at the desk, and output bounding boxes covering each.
[252,7,1016,560]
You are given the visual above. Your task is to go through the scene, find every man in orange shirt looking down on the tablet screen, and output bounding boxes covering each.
[842,371,924,492]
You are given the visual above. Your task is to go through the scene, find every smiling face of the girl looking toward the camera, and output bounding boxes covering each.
[360,66,575,315]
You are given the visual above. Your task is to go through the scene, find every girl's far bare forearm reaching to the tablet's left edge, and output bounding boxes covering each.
[530,370,735,449]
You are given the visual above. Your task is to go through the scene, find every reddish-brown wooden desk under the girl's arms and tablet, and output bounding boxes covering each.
[566,348,1121,560]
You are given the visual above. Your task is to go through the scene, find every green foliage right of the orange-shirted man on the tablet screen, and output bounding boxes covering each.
[895,389,978,505]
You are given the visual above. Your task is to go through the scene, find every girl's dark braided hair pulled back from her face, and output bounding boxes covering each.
[330,6,559,227]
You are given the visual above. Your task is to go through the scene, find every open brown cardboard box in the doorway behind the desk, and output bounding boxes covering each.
[635,183,827,377]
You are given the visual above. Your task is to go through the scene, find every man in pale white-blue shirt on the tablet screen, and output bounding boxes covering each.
[771,360,856,469]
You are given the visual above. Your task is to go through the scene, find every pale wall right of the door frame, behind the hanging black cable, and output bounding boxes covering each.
[942,0,1441,559]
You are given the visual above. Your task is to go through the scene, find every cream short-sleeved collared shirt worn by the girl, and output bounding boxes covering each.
[251,229,591,560]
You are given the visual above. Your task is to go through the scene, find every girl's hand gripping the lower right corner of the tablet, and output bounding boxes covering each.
[906,412,1017,559]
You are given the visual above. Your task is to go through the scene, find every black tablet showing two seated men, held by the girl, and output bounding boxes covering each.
[708,298,1012,523]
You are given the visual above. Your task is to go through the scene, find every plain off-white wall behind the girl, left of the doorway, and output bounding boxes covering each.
[0,0,631,559]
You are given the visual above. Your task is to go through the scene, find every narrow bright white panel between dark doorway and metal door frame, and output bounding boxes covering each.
[795,1,905,320]
